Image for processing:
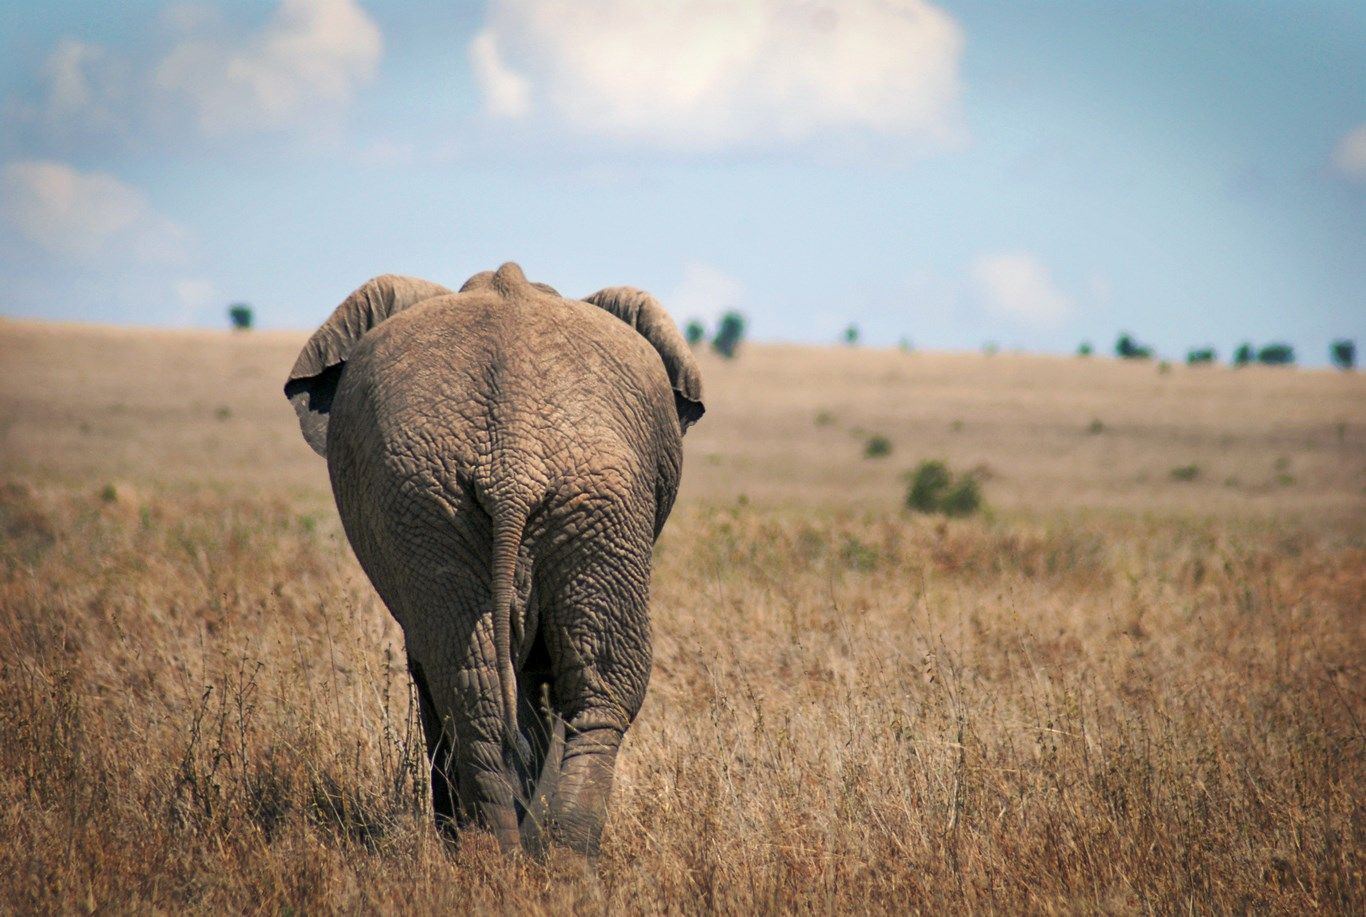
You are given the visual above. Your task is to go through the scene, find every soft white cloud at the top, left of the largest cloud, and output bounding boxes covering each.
[153,0,384,135]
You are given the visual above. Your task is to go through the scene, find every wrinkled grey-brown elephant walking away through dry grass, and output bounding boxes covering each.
[285,264,703,857]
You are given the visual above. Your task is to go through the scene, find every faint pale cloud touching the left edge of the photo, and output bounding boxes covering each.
[0,160,186,262]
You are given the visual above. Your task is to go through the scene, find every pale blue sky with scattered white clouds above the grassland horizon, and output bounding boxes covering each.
[0,0,1366,364]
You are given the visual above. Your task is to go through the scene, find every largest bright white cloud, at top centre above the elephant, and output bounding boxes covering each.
[470,0,963,149]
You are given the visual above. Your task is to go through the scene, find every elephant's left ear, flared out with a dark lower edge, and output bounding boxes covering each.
[284,273,451,456]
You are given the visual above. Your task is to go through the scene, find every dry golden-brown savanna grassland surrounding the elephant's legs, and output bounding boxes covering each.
[0,323,1366,913]
